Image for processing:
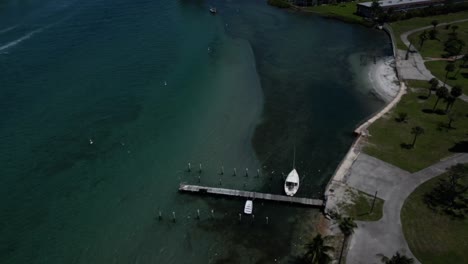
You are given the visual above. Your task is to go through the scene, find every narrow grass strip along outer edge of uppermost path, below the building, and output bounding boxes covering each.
[391,11,468,49]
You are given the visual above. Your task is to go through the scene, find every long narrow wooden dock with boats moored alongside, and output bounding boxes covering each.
[179,183,324,207]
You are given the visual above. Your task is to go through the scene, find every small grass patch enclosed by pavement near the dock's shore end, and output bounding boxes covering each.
[343,191,384,221]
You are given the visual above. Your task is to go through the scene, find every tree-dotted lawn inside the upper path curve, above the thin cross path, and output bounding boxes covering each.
[408,20,468,58]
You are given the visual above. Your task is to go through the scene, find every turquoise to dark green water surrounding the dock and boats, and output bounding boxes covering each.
[0,0,390,263]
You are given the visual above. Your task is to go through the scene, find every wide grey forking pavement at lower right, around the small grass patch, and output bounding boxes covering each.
[346,153,468,264]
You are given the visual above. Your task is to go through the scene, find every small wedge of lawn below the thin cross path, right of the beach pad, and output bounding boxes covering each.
[424,59,468,94]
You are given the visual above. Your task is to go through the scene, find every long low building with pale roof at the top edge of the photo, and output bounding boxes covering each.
[356,0,443,17]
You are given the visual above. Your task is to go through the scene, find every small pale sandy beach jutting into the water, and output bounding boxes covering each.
[368,57,400,103]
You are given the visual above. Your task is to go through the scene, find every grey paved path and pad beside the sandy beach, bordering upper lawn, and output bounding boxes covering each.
[397,19,468,102]
